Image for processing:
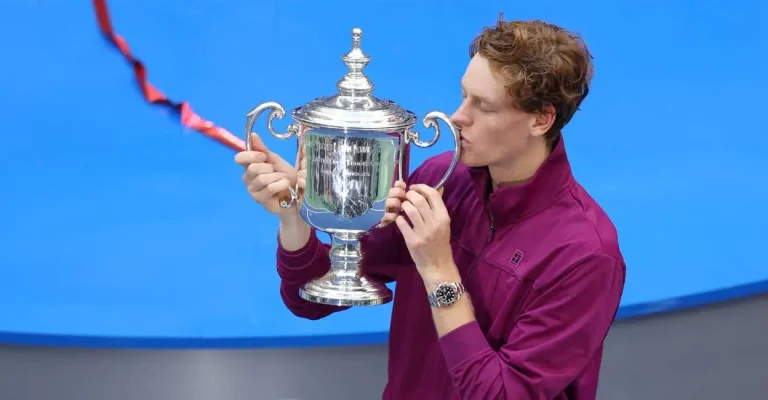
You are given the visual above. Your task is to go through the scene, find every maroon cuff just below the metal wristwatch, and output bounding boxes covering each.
[439,321,493,371]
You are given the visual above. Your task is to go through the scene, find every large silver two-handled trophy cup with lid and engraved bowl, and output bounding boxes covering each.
[245,28,460,306]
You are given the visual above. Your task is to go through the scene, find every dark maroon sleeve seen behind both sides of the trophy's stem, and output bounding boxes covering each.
[277,220,408,319]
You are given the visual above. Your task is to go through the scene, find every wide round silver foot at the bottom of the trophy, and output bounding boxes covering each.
[299,270,392,307]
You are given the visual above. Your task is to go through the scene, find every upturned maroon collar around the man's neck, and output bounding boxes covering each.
[470,136,573,228]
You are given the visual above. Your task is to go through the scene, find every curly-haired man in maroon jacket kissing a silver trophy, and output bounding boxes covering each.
[236,19,625,400]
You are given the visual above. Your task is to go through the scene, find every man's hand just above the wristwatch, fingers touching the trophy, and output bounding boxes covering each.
[395,184,456,285]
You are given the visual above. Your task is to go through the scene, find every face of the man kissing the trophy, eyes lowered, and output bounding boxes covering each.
[452,54,543,167]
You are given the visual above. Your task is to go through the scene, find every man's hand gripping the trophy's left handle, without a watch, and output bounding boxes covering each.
[235,134,298,217]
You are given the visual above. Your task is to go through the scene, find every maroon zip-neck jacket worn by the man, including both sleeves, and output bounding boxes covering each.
[277,139,625,400]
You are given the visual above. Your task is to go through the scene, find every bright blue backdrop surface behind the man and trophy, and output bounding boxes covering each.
[0,0,768,346]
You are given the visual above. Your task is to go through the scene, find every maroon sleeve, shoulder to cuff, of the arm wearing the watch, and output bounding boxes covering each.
[440,255,624,400]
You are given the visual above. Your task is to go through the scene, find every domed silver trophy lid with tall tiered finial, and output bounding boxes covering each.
[293,28,416,131]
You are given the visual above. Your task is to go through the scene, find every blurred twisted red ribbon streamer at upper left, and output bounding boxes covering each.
[93,0,249,151]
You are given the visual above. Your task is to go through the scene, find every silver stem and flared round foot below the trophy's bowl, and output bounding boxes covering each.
[300,231,392,306]
